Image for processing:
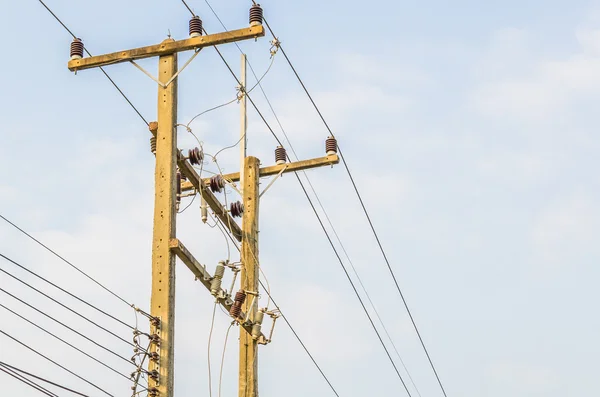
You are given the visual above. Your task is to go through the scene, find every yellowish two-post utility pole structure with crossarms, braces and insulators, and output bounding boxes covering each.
[68,4,340,397]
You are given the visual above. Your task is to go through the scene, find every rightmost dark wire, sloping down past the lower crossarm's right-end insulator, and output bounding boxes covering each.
[260,13,447,397]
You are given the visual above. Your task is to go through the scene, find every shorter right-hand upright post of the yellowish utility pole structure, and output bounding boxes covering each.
[239,157,260,397]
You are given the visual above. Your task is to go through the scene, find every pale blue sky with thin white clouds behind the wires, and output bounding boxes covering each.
[0,0,600,397]
